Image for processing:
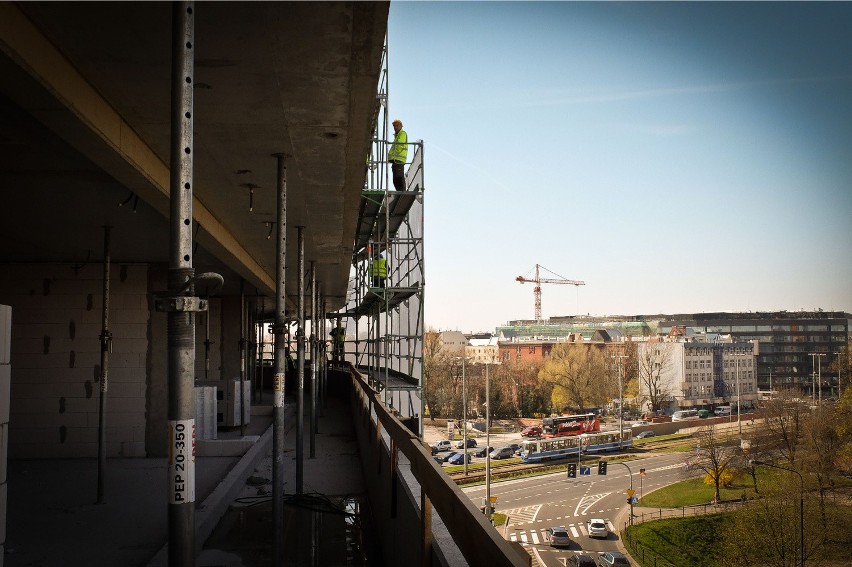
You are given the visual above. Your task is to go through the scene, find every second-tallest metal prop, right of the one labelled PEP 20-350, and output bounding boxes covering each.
[272,154,287,565]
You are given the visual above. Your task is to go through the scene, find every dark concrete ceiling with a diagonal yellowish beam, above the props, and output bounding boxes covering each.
[0,2,388,310]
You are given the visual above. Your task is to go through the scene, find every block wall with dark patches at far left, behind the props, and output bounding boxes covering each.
[0,263,150,458]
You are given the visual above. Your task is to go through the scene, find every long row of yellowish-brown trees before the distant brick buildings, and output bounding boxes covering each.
[423,331,852,418]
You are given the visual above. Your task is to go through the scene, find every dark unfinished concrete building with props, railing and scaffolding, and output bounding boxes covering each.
[0,2,529,565]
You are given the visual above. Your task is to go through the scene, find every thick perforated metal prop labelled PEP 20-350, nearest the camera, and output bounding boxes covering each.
[167,2,195,567]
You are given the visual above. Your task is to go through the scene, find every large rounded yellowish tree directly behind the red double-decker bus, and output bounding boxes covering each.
[539,343,609,409]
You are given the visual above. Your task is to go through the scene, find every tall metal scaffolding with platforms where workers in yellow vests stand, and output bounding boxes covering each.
[329,41,425,434]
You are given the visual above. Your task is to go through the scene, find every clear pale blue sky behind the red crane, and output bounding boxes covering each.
[388,1,852,332]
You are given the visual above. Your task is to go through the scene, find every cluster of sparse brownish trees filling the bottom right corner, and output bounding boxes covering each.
[694,388,852,567]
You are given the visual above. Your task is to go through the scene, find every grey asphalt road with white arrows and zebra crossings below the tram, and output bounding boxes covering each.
[464,453,697,567]
